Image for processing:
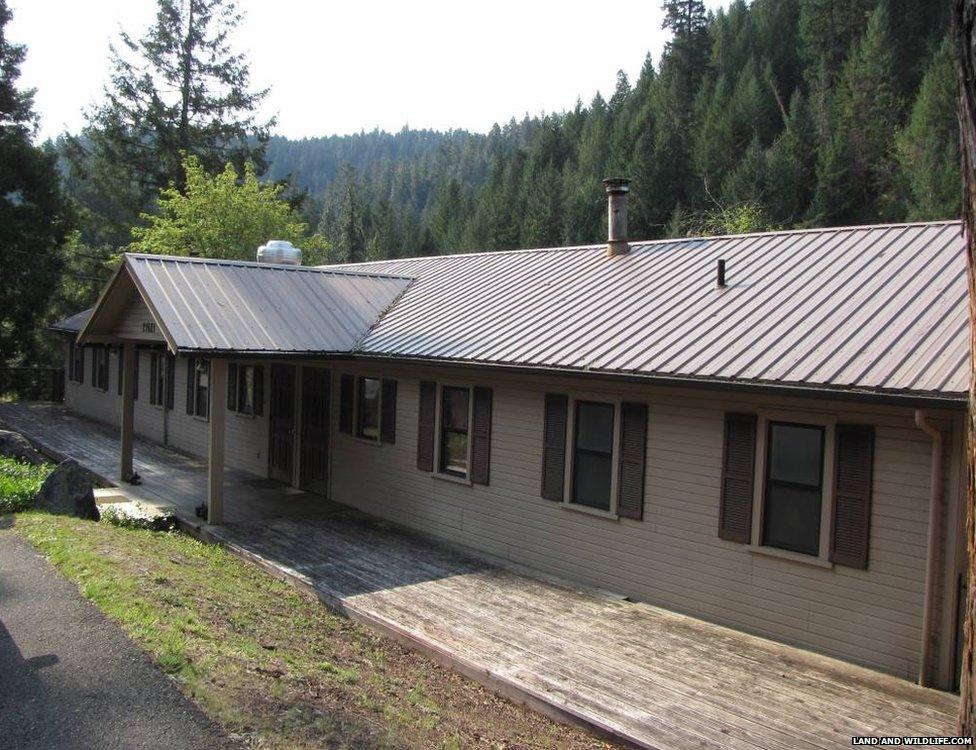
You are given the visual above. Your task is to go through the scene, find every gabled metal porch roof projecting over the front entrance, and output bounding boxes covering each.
[79,254,411,355]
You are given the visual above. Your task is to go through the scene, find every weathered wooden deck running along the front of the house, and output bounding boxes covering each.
[0,405,957,750]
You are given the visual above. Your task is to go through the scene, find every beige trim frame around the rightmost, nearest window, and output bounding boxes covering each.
[749,409,837,568]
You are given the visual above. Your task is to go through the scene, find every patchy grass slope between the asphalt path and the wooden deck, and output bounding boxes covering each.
[9,512,606,749]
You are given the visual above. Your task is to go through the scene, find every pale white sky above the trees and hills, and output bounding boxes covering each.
[7,0,723,141]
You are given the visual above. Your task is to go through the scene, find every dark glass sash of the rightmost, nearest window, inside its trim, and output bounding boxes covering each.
[762,422,824,555]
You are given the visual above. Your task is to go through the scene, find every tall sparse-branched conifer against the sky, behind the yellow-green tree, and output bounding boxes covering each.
[66,0,273,232]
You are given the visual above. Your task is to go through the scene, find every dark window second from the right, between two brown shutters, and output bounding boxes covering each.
[570,401,614,511]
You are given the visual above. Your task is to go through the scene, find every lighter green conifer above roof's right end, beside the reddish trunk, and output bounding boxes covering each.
[897,40,961,220]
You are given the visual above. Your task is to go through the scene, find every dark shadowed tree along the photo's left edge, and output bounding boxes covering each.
[0,0,71,366]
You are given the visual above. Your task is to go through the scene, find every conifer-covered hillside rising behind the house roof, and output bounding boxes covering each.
[267,0,959,260]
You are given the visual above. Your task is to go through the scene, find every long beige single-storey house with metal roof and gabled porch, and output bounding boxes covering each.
[51,183,969,689]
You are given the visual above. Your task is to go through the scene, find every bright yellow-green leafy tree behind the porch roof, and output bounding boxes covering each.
[129,156,329,265]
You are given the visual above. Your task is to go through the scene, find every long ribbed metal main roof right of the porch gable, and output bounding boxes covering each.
[333,222,969,399]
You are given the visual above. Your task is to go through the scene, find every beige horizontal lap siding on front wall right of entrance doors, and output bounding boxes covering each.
[332,366,952,678]
